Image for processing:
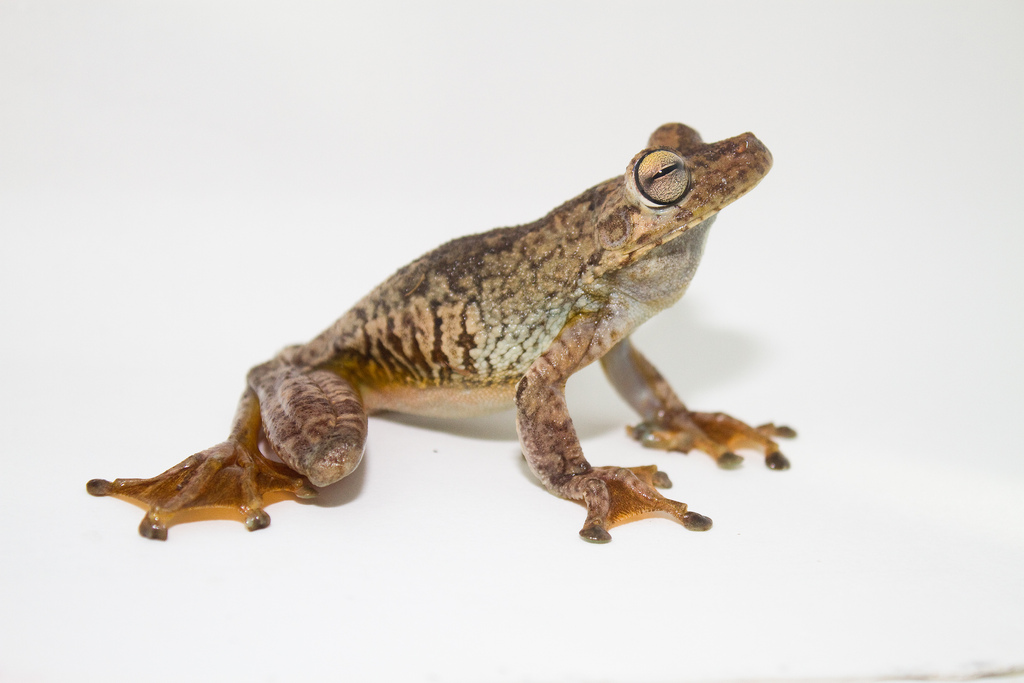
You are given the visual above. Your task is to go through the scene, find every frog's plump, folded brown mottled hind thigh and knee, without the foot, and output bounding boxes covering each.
[249,366,367,486]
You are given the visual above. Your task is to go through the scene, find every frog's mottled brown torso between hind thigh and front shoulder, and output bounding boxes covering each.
[286,204,594,415]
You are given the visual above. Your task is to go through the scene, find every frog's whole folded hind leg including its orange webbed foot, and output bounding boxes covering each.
[86,361,367,541]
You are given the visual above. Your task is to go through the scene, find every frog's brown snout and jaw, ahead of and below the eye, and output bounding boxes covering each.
[629,133,772,258]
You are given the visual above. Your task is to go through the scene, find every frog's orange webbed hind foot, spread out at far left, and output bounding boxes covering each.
[85,441,316,541]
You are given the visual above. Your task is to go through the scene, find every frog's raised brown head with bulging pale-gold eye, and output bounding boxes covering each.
[597,123,772,267]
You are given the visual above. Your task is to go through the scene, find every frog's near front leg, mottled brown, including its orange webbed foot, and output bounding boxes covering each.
[515,318,712,543]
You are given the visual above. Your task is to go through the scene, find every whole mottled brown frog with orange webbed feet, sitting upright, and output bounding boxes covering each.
[86,123,796,543]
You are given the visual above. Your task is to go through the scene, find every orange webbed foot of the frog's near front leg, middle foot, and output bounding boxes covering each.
[565,465,712,543]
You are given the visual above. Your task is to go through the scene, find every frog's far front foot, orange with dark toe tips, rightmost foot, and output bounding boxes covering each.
[626,411,797,470]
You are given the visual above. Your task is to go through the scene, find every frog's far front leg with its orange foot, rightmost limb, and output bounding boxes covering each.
[601,339,797,470]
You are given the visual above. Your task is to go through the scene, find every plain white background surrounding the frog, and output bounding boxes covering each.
[0,0,1024,683]
